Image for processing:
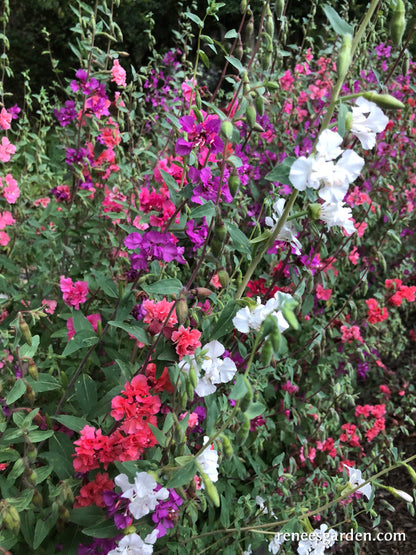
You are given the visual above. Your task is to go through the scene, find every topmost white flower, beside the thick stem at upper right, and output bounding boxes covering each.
[351,96,389,150]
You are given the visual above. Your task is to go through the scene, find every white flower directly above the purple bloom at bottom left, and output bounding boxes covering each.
[115,472,169,519]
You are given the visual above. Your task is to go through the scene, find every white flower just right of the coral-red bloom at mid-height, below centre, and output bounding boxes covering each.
[195,341,237,397]
